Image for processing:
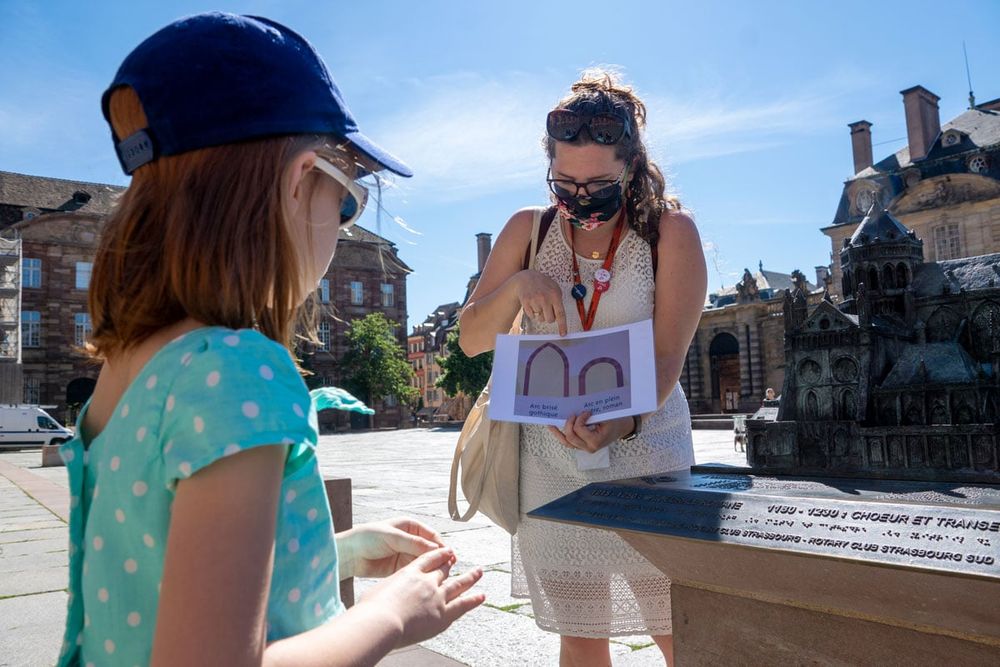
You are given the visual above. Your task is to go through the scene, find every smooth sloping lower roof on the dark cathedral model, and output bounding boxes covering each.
[882,342,980,389]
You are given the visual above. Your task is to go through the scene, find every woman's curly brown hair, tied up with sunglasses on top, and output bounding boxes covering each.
[545,69,681,245]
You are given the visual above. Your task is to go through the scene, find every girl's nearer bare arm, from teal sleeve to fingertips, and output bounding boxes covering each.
[151,446,484,666]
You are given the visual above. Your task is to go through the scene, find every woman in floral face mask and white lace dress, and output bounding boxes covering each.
[460,71,707,666]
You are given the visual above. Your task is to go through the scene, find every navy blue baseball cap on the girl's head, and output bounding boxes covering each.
[101,12,413,176]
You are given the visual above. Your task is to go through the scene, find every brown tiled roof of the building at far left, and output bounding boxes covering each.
[0,171,125,215]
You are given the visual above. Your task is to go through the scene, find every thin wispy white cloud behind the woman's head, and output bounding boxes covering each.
[372,72,865,206]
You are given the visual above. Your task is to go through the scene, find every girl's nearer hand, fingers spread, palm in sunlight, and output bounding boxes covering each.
[355,548,486,647]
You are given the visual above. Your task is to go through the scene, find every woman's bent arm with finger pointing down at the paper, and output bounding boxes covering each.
[458,209,566,357]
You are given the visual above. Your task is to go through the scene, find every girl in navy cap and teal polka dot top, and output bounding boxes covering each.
[60,13,483,665]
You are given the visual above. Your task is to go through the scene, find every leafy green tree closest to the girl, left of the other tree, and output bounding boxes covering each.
[341,313,419,406]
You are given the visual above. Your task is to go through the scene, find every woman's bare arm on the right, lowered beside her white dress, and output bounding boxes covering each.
[653,212,708,406]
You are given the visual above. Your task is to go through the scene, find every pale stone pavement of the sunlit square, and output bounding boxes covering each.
[0,427,742,667]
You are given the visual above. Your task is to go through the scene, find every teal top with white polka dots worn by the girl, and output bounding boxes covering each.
[59,327,343,665]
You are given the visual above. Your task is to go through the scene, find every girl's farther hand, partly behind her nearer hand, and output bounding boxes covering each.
[336,517,444,579]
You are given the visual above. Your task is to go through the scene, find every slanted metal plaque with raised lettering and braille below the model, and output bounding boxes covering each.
[529,472,1000,579]
